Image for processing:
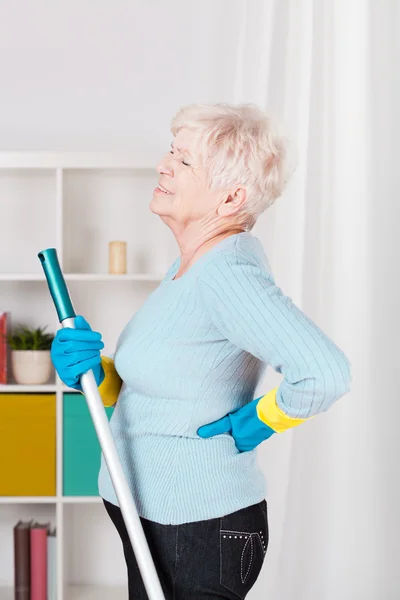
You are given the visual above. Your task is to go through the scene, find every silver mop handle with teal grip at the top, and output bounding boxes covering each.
[38,248,165,600]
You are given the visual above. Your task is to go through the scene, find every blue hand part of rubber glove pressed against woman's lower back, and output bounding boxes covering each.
[197,396,276,452]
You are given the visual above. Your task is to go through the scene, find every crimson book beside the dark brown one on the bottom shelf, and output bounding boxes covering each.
[30,523,50,600]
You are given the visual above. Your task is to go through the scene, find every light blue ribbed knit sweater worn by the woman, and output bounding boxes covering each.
[99,232,351,524]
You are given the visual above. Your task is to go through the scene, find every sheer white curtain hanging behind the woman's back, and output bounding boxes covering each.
[234,0,400,600]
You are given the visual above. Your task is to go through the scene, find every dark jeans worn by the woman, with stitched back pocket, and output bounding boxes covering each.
[103,500,269,600]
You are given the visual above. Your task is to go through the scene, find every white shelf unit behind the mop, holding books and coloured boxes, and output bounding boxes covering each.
[0,152,177,600]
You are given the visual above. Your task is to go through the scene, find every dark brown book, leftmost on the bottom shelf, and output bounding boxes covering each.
[14,521,32,600]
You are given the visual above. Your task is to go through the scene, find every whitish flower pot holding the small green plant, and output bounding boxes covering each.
[11,350,53,385]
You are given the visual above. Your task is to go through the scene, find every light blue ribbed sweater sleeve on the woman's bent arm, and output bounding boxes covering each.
[198,250,351,419]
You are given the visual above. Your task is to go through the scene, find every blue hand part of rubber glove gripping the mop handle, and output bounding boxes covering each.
[50,315,104,392]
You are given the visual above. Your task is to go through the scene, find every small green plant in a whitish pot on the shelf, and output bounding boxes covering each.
[7,325,55,385]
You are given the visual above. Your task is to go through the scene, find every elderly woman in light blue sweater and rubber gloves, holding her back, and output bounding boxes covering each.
[52,104,351,600]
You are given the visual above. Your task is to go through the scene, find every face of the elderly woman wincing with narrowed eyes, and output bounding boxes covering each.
[150,129,221,227]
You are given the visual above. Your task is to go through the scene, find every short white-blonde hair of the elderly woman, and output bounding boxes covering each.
[171,103,291,230]
